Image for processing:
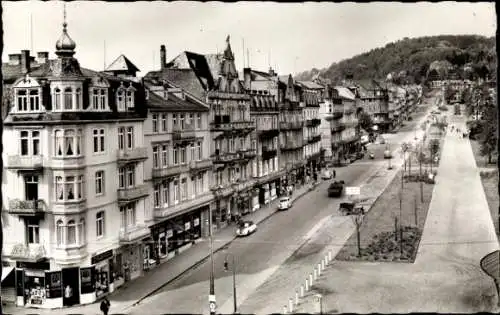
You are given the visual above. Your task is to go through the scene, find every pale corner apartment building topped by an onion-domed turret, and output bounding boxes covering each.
[2,22,149,308]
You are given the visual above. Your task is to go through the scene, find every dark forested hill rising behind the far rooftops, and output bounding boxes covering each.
[295,35,496,84]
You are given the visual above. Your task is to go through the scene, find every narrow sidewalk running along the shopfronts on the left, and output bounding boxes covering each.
[3,180,316,314]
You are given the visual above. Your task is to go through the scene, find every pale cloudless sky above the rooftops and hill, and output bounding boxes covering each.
[2,1,497,76]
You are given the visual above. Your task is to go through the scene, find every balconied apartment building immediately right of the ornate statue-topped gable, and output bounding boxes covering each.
[242,68,284,210]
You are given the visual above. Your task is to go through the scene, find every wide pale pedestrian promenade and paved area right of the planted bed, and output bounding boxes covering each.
[292,113,499,313]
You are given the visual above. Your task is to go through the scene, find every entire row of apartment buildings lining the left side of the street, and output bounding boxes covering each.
[2,17,422,308]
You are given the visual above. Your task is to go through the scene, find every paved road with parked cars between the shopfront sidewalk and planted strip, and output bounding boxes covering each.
[129,100,436,314]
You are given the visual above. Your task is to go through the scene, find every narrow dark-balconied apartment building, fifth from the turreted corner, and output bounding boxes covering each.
[278,75,306,185]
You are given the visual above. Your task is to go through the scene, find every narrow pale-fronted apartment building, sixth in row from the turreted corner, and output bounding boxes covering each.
[297,81,324,172]
